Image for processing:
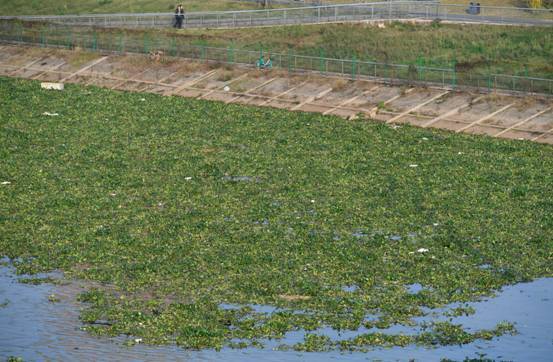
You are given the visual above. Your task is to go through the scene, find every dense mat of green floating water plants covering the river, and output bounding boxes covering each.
[0,78,553,350]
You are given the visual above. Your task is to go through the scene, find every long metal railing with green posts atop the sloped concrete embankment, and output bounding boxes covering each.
[0,20,553,95]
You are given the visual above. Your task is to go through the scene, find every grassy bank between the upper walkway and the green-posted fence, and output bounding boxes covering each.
[7,23,553,78]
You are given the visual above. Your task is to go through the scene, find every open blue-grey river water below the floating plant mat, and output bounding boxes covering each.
[0,266,553,362]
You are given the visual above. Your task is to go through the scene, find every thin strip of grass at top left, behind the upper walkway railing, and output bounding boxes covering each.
[0,0,257,15]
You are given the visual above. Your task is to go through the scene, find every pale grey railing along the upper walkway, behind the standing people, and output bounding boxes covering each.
[0,1,553,28]
